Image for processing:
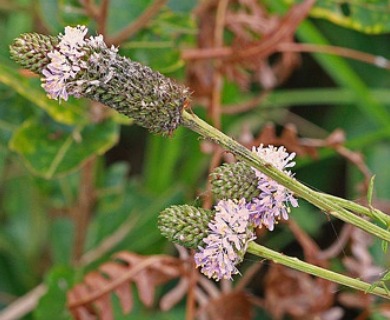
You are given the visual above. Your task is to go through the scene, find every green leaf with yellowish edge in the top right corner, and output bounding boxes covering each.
[288,0,390,34]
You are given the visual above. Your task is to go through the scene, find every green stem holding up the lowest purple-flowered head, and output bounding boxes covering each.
[247,241,390,299]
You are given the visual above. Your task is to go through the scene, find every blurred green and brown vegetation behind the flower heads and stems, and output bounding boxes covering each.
[0,0,390,320]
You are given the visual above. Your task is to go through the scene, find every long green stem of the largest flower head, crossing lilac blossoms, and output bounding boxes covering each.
[183,111,390,241]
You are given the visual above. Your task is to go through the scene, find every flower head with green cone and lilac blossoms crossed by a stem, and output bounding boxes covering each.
[210,145,298,231]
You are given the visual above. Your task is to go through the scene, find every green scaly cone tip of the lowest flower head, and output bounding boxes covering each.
[158,205,214,249]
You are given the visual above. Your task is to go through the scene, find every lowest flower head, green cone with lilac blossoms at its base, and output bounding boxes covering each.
[158,199,255,280]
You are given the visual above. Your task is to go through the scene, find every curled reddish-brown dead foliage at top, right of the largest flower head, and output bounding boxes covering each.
[186,0,314,99]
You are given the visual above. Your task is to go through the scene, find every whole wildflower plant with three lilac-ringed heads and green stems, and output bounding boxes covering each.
[10,26,390,298]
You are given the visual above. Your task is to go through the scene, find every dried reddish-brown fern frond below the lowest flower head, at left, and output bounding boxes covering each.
[68,251,186,320]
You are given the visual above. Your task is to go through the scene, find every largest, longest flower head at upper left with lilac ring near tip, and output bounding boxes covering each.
[10,26,189,134]
